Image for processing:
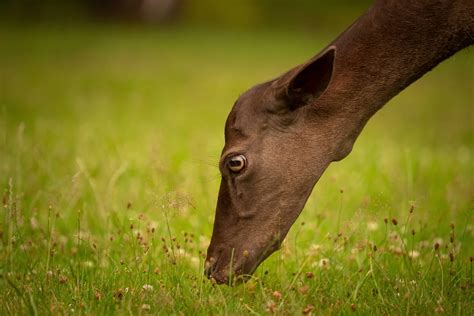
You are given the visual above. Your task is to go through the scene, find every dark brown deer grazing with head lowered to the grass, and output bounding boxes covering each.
[204,0,474,284]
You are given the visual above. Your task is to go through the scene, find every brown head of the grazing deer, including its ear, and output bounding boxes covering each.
[206,47,352,283]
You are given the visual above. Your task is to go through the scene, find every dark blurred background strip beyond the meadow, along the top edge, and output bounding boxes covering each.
[0,0,371,29]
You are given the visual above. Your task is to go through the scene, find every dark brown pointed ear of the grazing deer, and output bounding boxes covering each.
[275,46,336,110]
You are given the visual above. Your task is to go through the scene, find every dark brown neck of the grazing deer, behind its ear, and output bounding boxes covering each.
[322,0,474,126]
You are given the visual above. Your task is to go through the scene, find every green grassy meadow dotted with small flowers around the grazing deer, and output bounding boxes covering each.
[0,26,474,315]
